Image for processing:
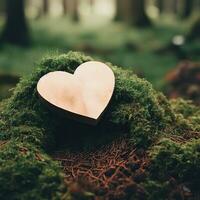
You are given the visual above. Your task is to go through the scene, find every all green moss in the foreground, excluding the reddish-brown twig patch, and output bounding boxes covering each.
[0,52,200,199]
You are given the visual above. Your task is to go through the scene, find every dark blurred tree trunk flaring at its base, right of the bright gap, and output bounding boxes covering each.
[131,0,151,27]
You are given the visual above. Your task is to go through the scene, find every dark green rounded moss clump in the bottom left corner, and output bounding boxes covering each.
[0,141,66,200]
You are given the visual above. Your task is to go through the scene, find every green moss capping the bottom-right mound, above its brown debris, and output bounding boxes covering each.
[149,139,200,191]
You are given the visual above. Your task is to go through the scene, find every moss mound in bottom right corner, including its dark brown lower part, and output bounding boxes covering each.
[141,139,200,199]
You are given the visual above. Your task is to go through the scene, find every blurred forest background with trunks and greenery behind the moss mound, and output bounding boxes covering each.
[0,0,200,100]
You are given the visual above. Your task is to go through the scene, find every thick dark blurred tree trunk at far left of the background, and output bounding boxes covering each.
[1,0,30,45]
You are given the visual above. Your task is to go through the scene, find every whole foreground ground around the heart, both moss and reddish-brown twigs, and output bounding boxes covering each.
[0,52,200,200]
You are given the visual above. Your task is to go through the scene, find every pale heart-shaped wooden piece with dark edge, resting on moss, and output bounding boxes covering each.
[37,61,115,125]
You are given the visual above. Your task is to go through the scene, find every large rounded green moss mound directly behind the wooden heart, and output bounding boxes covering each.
[1,52,178,150]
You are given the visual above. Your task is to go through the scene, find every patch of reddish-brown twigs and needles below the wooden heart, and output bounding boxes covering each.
[53,139,148,200]
